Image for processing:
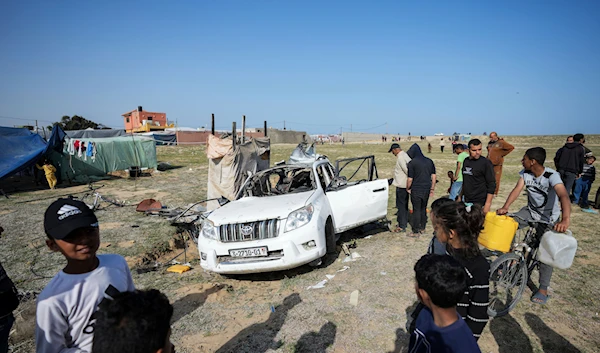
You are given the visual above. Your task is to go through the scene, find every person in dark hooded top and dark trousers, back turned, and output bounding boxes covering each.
[406,143,436,238]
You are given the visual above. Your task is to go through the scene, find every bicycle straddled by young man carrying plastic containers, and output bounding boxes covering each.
[488,214,551,317]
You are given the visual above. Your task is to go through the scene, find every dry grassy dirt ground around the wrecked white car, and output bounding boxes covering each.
[0,135,600,353]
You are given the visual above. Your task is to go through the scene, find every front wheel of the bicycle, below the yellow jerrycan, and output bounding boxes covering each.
[488,253,527,317]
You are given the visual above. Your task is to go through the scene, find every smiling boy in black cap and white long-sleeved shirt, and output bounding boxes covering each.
[35,198,135,352]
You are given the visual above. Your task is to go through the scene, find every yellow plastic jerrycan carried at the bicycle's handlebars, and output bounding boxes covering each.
[477,212,519,252]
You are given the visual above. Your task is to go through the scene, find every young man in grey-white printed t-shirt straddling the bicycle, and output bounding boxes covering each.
[496,147,571,304]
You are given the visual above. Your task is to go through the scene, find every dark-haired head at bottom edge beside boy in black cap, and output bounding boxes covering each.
[92,289,175,353]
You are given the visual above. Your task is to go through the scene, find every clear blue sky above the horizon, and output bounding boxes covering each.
[0,0,600,135]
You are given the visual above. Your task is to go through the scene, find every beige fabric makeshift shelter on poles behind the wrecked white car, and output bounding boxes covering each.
[206,135,271,210]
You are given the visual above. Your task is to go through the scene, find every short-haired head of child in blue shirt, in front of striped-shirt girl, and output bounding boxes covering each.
[415,254,467,308]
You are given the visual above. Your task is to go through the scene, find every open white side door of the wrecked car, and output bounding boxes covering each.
[325,157,388,233]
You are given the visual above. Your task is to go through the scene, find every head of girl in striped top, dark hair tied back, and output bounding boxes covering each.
[431,200,485,256]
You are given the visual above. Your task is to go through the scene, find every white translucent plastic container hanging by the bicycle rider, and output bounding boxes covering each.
[538,229,577,270]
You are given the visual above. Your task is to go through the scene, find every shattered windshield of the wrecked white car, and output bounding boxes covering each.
[242,166,317,197]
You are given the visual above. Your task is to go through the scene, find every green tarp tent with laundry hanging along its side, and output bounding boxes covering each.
[49,135,156,182]
